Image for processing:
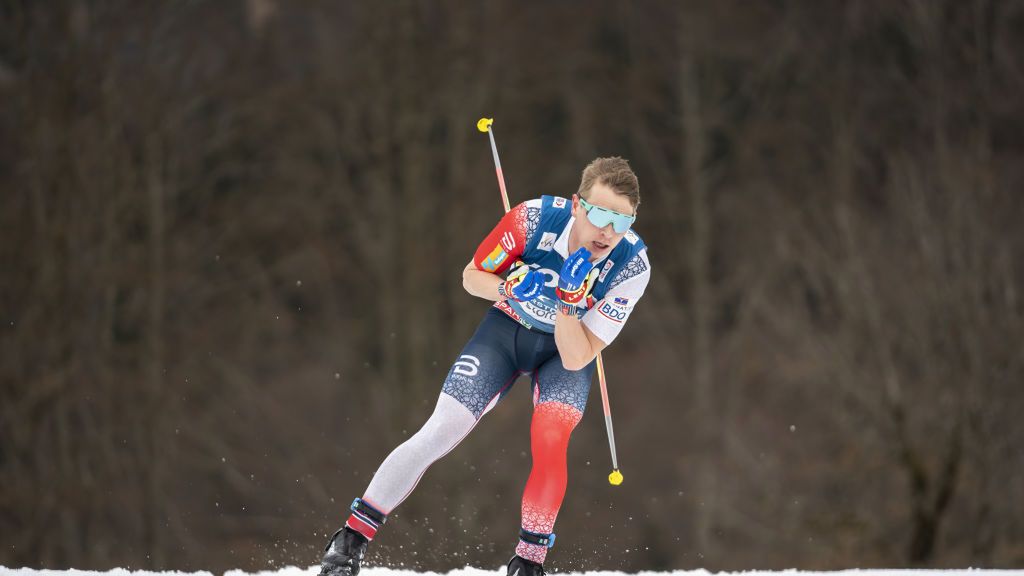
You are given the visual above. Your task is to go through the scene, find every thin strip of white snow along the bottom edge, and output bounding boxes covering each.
[0,566,1024,576]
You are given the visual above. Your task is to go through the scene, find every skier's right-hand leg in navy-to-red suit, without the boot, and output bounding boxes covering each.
[516,356,594,564]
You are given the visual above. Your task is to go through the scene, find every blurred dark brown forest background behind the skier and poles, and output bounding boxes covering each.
[0,0,1024,572]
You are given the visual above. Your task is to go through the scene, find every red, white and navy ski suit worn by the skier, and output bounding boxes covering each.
[347,196,650,563]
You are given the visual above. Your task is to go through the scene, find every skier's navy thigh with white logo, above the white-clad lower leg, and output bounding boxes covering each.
[441,312,520,418]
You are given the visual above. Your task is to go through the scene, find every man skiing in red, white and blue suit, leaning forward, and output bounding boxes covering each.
[321,158,650,576]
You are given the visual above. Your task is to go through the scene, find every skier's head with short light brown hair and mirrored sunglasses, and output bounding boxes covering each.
[572,157,640,261]
